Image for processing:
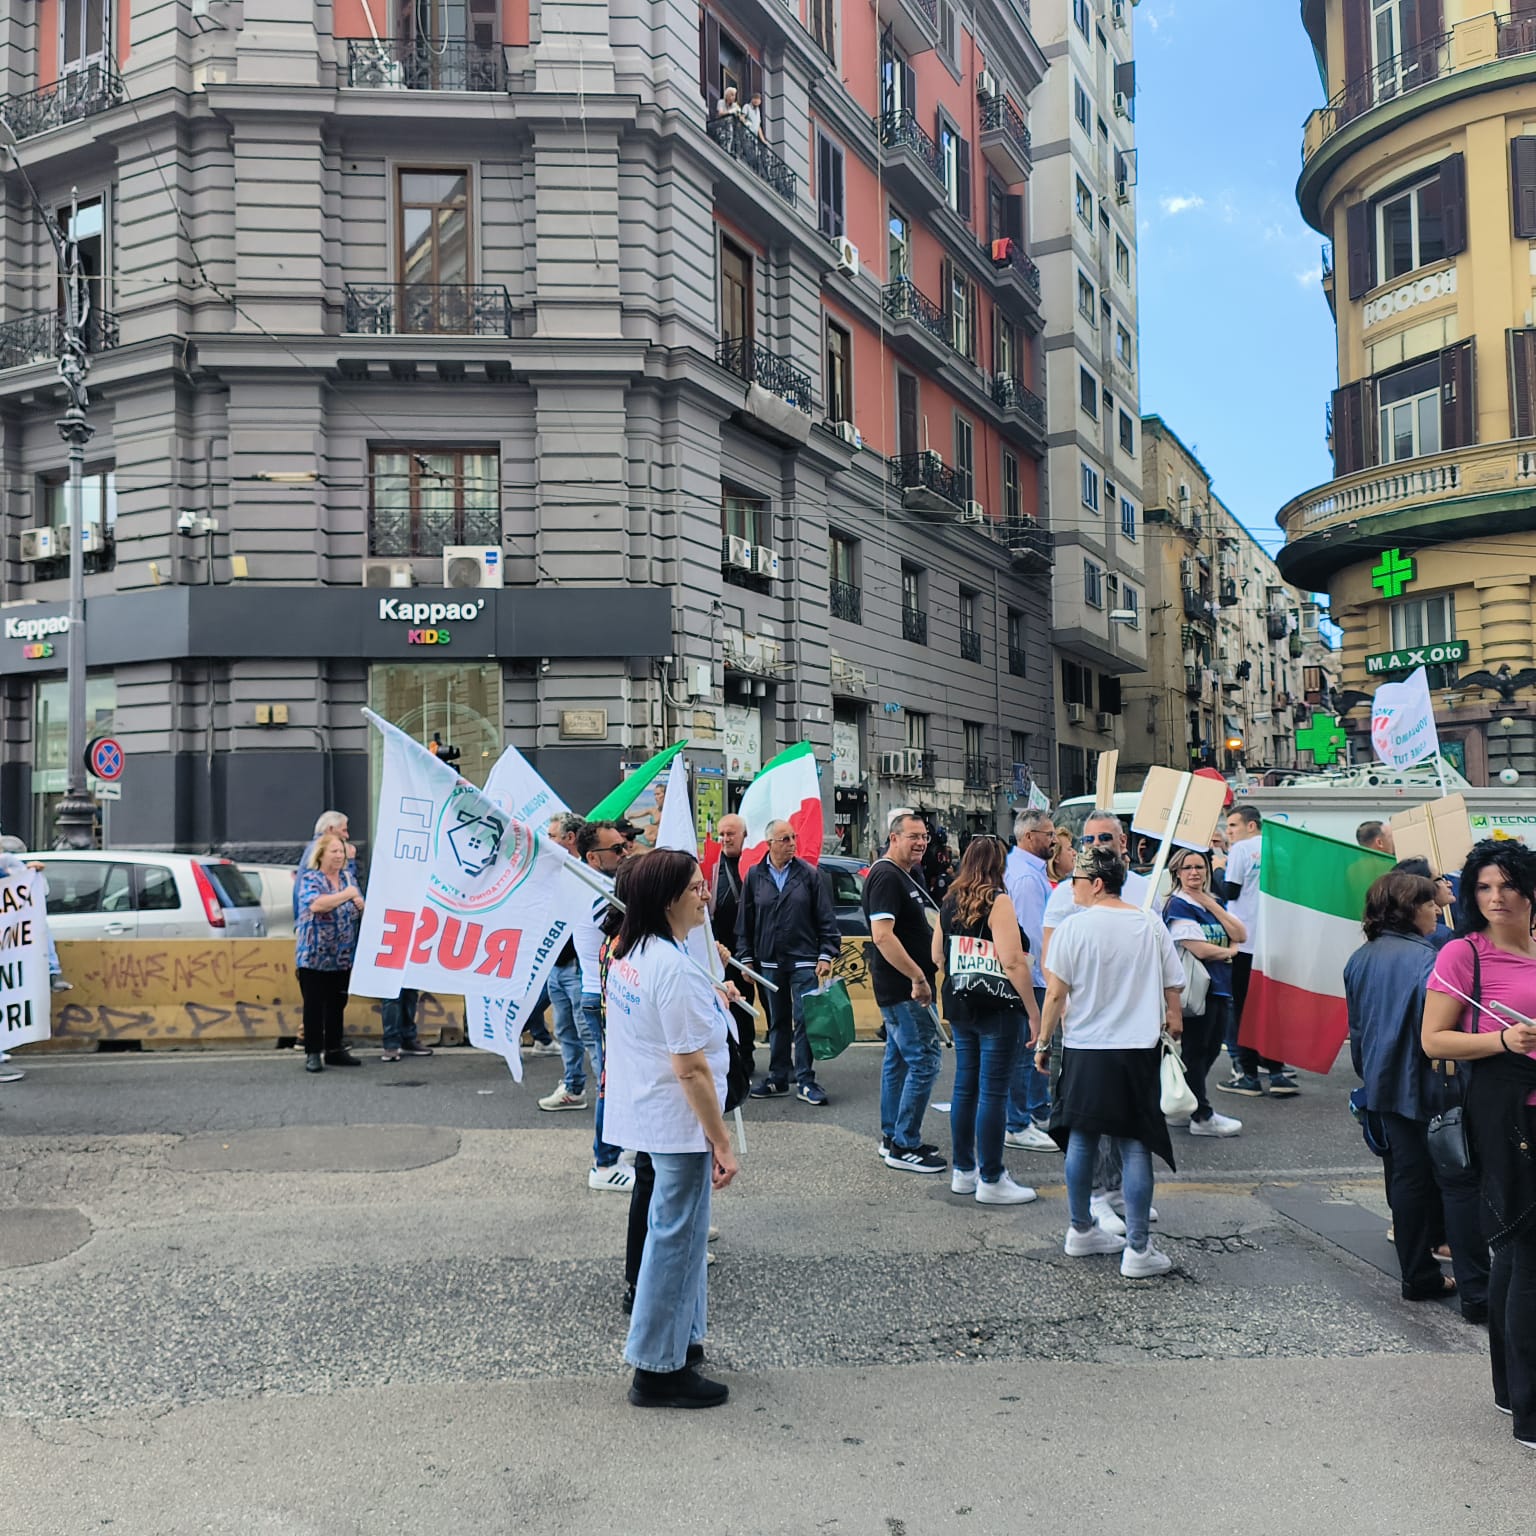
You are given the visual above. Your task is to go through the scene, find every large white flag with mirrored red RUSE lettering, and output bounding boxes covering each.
[352,710,591,1074]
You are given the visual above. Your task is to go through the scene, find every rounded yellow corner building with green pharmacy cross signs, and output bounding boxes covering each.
[1279,0,1536,783]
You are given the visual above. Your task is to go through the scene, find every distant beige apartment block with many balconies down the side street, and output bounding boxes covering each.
[1120,416,1327,774]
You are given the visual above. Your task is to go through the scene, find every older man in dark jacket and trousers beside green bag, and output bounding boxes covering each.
[736,822,842,1109]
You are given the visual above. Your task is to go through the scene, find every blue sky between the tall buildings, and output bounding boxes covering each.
[1135,0,1336,550]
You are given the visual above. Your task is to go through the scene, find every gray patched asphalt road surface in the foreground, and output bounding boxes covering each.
[0,1046,1536,1536]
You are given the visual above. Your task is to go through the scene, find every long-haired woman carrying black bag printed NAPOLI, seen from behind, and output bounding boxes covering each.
[932,836,1040,1206]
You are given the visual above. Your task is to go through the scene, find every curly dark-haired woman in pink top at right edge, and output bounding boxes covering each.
[1422,840,1536,1450]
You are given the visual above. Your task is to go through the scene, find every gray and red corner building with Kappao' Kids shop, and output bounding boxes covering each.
[0,0,1052,852]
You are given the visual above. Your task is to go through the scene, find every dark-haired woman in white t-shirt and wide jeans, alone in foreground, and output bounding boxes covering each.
[604,848,737,1409]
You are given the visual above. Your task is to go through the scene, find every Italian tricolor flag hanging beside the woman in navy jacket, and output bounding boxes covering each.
[1238,822,1392,1072]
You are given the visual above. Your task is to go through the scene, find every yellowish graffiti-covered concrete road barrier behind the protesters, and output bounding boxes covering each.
[26,937,880,1051]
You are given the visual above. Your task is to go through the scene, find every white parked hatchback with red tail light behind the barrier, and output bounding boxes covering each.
[22,848,267,938]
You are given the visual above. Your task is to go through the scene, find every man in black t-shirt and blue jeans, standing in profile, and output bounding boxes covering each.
[863,813,946,1174]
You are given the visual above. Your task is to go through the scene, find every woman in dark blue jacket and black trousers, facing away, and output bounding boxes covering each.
[1344,869,1488,1321]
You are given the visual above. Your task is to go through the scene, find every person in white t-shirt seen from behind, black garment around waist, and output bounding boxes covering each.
[1035,848,1184,1279]
